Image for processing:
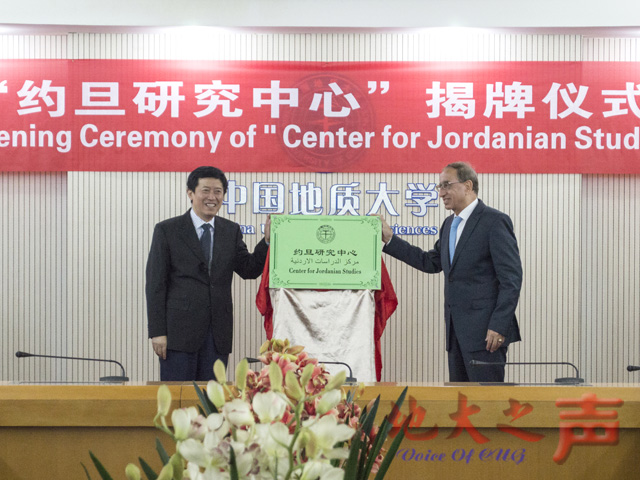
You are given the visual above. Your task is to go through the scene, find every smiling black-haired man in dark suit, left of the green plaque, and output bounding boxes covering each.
[146,167,270,381]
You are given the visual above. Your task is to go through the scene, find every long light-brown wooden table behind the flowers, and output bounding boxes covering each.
[0,383,640,480]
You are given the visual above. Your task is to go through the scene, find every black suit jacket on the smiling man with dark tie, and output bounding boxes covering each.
[146,211,268,354]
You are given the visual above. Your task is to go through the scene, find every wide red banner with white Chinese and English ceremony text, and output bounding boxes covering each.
[0,60,640,174]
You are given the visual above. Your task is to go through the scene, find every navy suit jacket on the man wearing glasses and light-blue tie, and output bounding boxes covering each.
[383,200,522,352]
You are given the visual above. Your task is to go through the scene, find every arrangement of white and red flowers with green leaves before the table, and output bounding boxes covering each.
[85,340,410,480]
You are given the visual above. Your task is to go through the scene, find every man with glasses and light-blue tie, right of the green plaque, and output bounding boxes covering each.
[381,163,522,382]
